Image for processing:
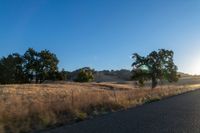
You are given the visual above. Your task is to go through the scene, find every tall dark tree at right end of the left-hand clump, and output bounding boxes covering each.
[24,48,59,83]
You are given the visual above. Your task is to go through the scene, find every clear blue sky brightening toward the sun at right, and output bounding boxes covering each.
[0,0,200,74]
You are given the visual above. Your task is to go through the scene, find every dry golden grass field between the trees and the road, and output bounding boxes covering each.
[0,77,200,133]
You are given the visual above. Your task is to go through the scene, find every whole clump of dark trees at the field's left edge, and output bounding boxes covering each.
[0,48,60,84]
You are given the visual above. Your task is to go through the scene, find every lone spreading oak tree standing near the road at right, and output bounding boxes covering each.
[132,49,179,88]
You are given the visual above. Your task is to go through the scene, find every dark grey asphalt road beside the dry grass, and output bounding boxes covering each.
[41,90,200,133]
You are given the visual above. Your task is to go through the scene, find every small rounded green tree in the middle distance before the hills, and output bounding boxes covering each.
[75,68,94,82]
